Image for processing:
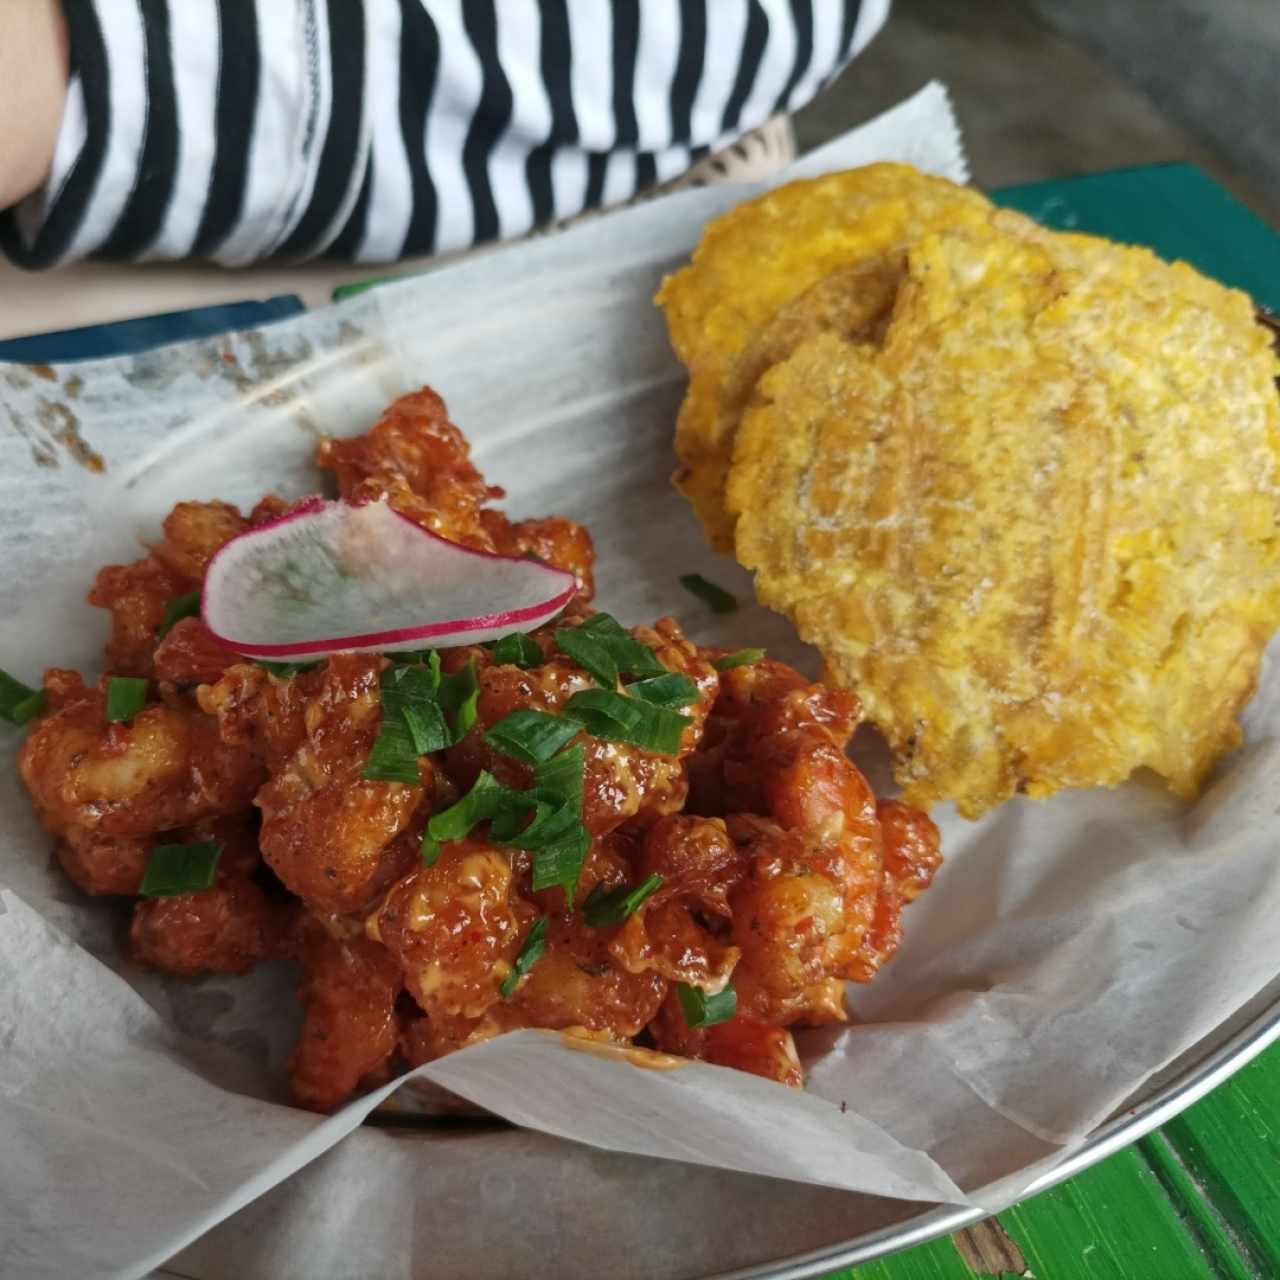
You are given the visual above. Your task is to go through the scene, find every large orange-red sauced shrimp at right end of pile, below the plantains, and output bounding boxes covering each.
[694,660,937,1025]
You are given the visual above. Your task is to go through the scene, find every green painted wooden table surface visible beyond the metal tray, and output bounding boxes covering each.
[335,164,1280,1280]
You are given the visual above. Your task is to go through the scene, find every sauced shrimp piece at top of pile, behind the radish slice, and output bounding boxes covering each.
[316,387,595,599]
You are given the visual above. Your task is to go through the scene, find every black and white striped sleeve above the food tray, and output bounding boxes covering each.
[0,0,888,268]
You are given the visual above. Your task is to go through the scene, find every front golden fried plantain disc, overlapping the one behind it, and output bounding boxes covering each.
[727,215,1280,815]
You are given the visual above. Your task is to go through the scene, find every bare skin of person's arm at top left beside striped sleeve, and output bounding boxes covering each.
[0,0,67,209]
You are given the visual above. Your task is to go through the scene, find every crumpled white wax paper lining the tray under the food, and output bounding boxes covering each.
[0,87,1280,1277]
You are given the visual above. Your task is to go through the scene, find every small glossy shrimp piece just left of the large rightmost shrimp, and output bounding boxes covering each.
[609,814,745,992]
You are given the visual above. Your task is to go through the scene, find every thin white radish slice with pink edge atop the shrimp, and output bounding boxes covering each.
[201,498,576,658]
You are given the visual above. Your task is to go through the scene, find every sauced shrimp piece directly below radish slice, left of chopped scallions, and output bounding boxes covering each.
[252,653,434,914]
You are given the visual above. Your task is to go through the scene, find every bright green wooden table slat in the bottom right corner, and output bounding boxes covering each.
[1161,1044,1280,1276]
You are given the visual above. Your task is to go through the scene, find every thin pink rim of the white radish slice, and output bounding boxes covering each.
[200,497,577,658]
